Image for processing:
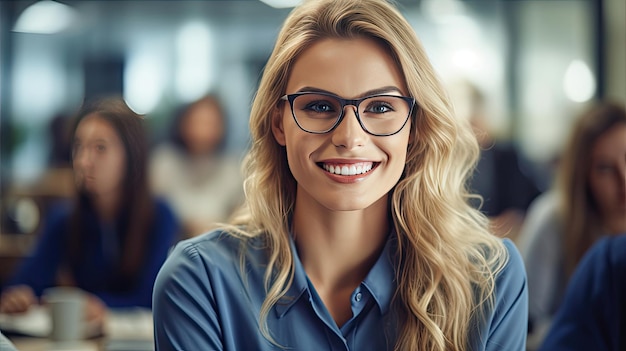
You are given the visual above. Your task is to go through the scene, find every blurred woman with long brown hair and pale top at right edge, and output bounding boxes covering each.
[520,103,626,346]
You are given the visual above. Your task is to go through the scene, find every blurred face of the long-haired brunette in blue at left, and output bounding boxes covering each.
[72,114,126,196]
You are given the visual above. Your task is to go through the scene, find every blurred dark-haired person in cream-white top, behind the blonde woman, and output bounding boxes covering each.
[150,95,243,237]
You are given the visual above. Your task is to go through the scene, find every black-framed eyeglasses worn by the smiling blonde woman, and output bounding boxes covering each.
[280,92,415,136]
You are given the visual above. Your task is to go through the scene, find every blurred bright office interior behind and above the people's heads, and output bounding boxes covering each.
[0,0,626,242]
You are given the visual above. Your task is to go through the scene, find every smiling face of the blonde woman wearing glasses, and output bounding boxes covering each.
[273,38,411,211]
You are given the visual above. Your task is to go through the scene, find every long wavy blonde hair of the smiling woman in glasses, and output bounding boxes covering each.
[225,0,508,350]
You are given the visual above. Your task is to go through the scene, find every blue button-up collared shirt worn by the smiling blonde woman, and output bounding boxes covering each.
[153,231,528,351]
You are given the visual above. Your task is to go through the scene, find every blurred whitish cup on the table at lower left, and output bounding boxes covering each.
[43,287,86,341]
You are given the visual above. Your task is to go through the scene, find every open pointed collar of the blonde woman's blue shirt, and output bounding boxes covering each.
[275,230,397,318]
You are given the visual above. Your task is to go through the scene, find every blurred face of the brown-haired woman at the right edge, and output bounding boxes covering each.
[589,124,626,230]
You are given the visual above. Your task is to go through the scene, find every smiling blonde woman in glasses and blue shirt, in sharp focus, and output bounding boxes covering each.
[153,0,528,351]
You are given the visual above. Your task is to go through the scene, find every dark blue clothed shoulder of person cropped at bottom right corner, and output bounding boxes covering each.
[540,233,626,351]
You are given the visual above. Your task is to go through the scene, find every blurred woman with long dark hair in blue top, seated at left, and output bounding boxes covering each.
[0,98,179,328]
